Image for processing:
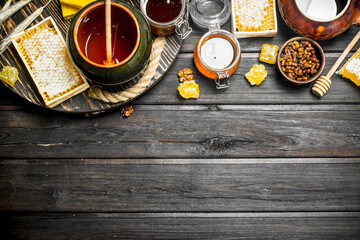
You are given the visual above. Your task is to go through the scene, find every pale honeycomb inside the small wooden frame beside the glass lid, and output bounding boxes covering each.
[233,0,275,32]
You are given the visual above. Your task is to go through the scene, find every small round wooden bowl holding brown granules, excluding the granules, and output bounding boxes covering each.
[276,37,325,85]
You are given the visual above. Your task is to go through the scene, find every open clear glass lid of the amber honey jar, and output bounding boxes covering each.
[189,0,231,28]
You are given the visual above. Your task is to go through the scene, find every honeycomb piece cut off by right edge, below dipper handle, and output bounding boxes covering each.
[339,48,360,86]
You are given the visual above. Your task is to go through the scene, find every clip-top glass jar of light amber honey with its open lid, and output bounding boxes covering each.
[190,0,241,89]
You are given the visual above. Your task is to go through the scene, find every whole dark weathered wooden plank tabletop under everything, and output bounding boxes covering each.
[0,0,360,239]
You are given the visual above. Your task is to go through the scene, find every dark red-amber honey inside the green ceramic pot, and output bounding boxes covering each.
[76,5,139,65]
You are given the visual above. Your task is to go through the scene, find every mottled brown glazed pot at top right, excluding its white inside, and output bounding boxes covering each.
[278,0,360,39]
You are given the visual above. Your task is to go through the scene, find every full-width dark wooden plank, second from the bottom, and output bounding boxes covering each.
[0,159,360,212]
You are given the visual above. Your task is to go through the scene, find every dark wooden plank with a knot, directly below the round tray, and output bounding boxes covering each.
[0,105,360,158]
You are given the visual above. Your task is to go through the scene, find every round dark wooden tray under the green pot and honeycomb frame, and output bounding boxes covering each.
[0,0,182,114]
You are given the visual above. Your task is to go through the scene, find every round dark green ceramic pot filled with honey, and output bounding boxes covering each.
[66,0,152,85]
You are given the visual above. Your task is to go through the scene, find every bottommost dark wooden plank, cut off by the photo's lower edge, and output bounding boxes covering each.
[0,213,360,239]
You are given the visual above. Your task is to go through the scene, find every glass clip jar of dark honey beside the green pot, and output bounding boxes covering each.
[140,0,192,39]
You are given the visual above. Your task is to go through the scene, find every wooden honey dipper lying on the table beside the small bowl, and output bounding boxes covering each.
[311,31,360,97]
